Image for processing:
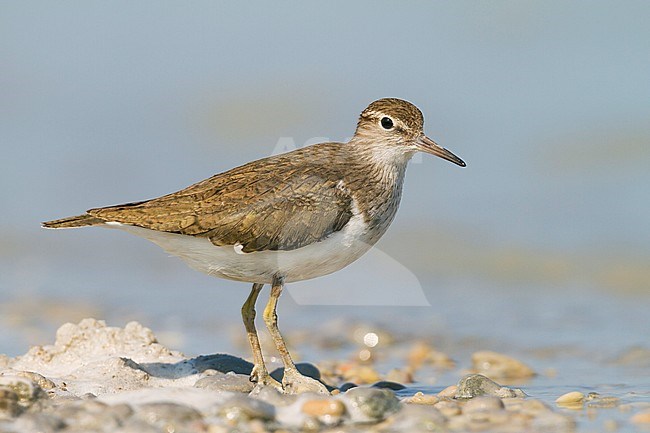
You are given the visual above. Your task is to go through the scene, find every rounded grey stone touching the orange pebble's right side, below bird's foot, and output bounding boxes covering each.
[343,388,400,422]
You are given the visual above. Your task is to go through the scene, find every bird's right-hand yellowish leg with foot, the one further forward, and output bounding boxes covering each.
[264,277,329,394]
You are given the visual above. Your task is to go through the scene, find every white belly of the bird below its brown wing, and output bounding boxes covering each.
[105,215,372,283]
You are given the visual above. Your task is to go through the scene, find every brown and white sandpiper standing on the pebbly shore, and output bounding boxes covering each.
[42,98,466,394]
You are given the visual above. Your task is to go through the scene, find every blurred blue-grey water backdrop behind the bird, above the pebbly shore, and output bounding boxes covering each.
[0,0,650,368]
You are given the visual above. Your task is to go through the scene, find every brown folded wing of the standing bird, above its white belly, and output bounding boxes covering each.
[88,147,352,252]
